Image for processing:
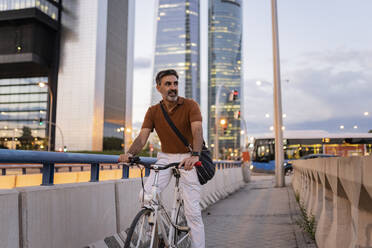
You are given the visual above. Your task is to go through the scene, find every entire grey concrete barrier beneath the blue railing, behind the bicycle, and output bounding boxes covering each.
[0,168,244,248]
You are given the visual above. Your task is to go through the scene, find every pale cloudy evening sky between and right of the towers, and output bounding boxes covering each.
[133,0,372,134]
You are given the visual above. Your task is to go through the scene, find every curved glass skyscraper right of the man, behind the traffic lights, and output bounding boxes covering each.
[208,0,242,159]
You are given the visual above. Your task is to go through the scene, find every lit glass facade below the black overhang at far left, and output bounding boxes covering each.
[0,77,48,149]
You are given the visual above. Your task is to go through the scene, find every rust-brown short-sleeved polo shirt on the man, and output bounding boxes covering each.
[142,97,202,153]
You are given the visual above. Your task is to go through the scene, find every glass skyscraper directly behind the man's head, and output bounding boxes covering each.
[151,0,200,104]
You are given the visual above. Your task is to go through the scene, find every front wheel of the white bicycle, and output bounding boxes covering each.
[124,209,155,248]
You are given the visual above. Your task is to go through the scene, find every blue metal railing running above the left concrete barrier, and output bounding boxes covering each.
[0,149,241,185]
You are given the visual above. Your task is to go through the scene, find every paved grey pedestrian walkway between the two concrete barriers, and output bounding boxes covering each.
[203,176,316,248]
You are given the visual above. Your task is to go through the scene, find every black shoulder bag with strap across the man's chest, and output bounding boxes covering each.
[160,103,216,185]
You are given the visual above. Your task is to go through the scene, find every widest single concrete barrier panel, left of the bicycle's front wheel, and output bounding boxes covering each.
[17,181,116,248]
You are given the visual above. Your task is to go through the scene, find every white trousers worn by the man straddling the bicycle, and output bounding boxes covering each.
[145,152,205,248]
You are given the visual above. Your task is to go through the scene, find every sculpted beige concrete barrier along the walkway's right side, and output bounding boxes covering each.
[292,156,372,248]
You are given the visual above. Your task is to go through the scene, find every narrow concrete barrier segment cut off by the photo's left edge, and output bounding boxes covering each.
[0,190,19,248]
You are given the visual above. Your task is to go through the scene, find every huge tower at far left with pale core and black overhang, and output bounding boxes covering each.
[0,0,134,150]
